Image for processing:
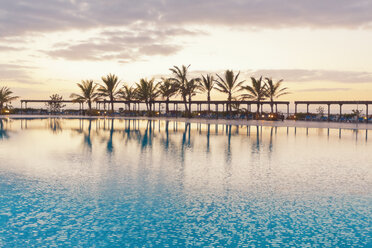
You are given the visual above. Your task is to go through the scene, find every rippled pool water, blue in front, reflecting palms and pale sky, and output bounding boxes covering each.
[0,119,372,247]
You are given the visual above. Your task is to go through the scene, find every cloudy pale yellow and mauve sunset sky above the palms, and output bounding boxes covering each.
[0,0,372,105]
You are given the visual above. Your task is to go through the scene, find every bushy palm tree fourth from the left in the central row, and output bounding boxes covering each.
[136,78,159,111]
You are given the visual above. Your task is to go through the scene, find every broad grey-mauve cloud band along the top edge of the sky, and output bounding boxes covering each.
[0,0,372,37]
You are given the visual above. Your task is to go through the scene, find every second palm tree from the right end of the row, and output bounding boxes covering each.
[240,76,267,115]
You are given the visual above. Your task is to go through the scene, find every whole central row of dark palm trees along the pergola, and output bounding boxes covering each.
[71,65,288,115]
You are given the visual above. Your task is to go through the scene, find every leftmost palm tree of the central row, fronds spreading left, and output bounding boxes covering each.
[70,80,99,112]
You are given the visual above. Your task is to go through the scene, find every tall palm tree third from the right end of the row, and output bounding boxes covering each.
[216,70,244,114]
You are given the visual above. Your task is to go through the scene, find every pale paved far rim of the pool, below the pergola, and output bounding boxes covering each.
[0,115,372,130]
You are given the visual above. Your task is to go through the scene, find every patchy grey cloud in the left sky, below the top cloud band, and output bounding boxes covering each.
[42,27,193,60]
